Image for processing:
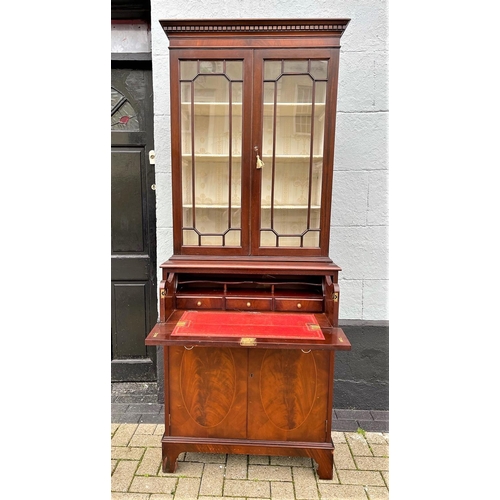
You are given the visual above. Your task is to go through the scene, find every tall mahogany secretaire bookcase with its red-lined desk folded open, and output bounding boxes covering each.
[146,19,351,479]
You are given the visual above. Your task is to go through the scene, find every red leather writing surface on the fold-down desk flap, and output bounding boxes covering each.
[172,311,325,340]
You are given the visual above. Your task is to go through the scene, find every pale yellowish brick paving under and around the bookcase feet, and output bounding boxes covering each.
[111,423,389,500]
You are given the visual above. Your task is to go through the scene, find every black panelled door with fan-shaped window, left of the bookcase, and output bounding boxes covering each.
[111,63,157,382]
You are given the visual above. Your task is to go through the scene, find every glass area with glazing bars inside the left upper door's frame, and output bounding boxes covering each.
[181,61,242,246]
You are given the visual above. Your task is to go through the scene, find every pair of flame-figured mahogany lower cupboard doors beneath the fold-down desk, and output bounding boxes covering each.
[166,346,333,442]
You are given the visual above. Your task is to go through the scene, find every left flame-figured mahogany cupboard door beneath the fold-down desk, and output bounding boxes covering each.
[166,347,248,438]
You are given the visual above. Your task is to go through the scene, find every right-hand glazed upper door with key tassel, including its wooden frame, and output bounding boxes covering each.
[252,49,338,256]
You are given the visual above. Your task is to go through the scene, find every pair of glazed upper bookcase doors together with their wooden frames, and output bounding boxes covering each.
[171,48,338,256]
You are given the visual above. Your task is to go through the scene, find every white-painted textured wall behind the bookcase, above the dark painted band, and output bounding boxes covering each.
[151,0,389,320]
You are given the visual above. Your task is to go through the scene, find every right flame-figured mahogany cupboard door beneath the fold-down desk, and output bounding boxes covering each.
[248,349,333,442]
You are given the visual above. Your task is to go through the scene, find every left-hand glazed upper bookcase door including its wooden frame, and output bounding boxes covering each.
[170,50,252,255]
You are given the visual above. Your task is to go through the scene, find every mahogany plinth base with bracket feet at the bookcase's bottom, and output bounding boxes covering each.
[161,435,334,479]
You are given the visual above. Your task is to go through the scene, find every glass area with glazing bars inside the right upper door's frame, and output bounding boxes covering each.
[260,60,327,248]
